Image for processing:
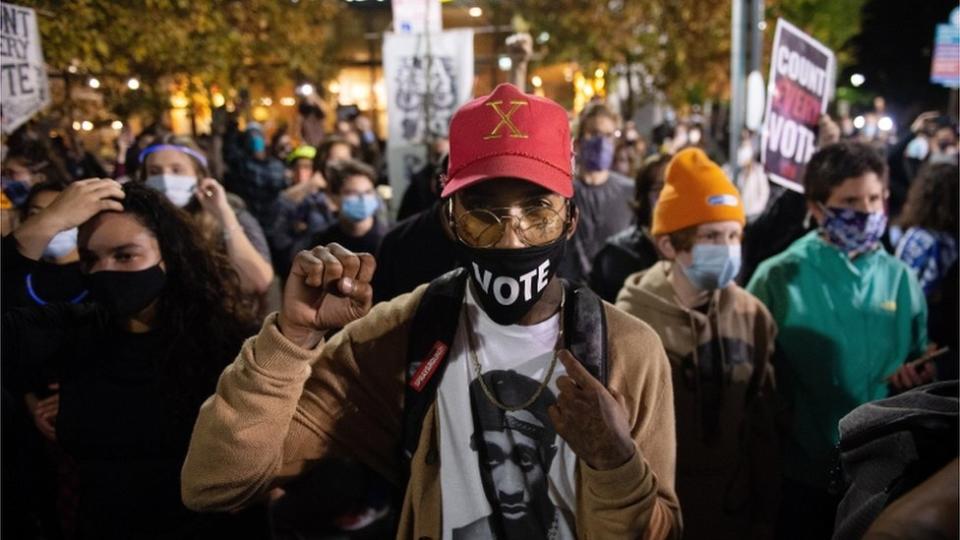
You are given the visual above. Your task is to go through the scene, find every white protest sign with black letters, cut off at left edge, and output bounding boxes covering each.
[0,3,50,134]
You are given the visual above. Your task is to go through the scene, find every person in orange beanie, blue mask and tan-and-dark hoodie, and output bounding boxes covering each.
[617,148,780,539]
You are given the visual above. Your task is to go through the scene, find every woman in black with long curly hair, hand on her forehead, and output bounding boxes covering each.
[2,179,262,539]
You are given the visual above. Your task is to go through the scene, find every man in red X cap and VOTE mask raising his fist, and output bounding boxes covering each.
[182,84,680,539]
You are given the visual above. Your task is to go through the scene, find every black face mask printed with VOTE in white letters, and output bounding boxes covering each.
[456,240,567,325]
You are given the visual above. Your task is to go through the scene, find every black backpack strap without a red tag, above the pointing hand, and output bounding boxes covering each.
[563,281,608,386]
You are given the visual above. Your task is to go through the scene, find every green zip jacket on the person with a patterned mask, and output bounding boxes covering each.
[747,231,927,488]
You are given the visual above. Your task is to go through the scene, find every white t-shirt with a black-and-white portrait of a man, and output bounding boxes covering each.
[437,287,577,540]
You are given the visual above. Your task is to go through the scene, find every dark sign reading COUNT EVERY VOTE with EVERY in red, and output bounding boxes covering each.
[761,19,834,193]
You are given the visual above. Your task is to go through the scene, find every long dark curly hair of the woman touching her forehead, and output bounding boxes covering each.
[105,183,254,414]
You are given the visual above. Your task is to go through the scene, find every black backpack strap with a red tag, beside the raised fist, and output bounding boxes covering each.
[400,268,467,483]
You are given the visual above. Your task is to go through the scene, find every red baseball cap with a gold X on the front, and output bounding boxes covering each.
[441,83,573,198]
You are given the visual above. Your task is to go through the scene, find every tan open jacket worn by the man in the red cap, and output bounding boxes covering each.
[182,285,681,539]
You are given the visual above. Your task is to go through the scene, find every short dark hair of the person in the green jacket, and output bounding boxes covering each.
[803,141,887,203]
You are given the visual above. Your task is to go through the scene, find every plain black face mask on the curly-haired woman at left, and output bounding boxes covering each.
[86,265,167,317]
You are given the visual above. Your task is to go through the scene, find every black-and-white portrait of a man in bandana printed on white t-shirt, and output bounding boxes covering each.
[453,370,573,540]
